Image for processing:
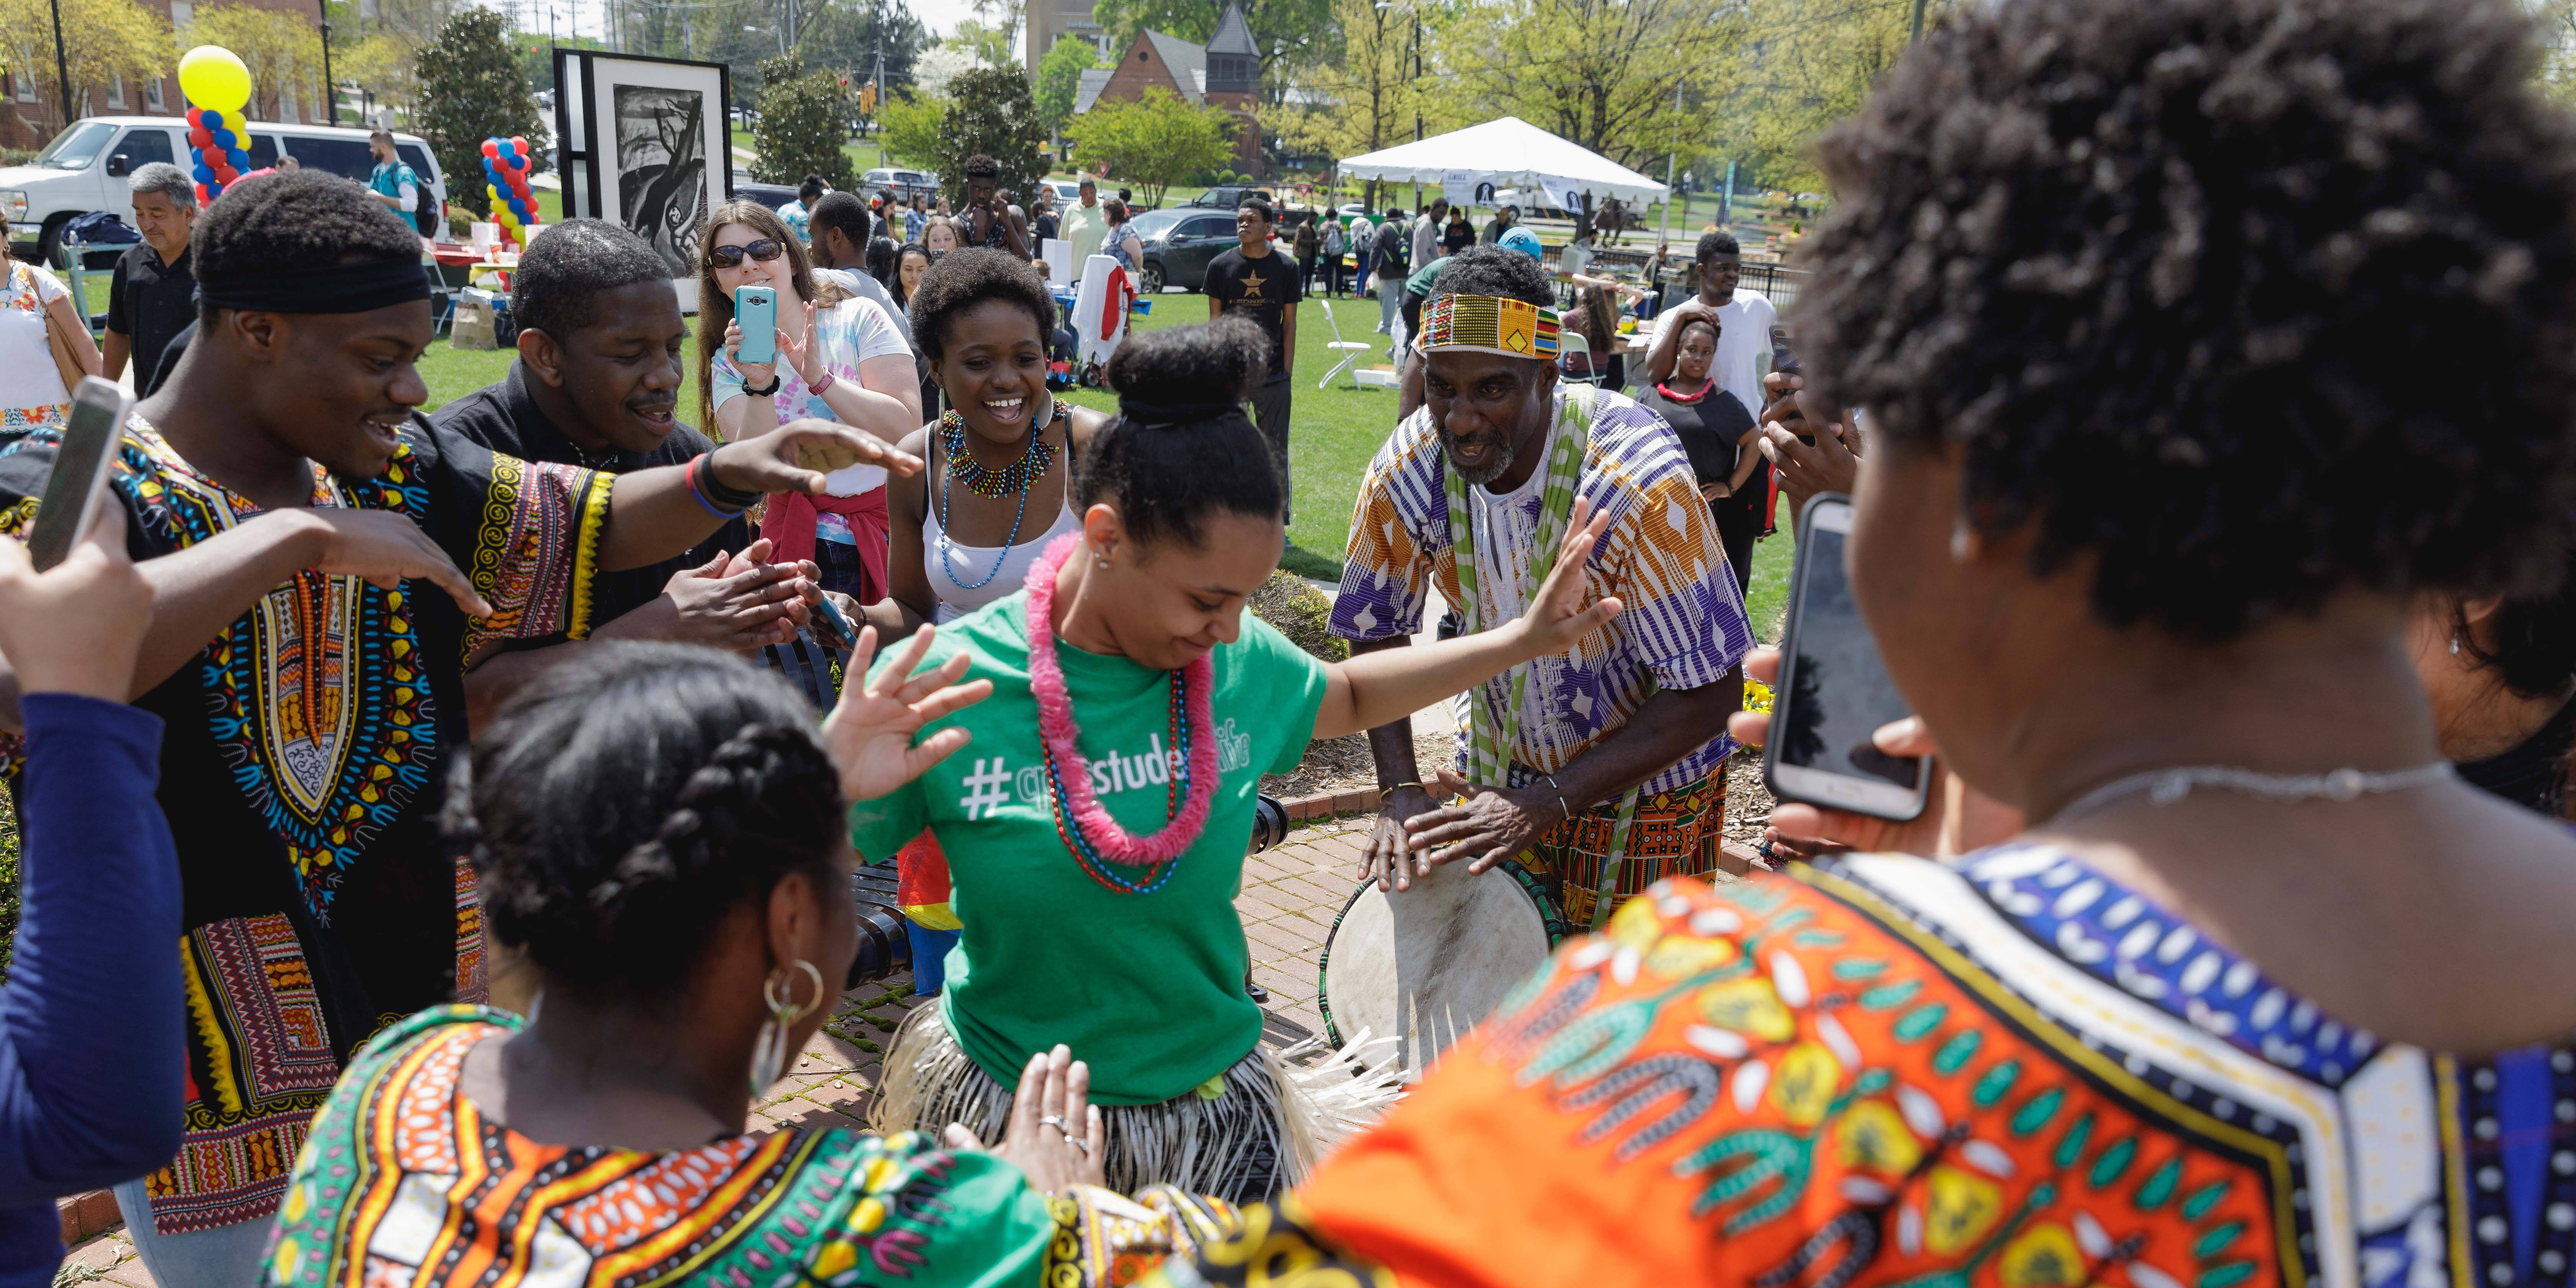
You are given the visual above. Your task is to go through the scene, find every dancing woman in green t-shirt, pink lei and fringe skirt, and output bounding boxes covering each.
[850,319,1618,1201]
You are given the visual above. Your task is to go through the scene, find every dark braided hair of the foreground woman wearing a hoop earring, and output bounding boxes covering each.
[446,641,842,999]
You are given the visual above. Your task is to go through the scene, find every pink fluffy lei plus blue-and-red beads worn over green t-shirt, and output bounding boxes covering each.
[1023,533,1224,894]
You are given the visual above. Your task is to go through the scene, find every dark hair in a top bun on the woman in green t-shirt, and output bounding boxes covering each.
[1074,314,1288,546]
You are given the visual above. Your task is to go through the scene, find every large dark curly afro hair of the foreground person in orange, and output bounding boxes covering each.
[1798,0,2576,641]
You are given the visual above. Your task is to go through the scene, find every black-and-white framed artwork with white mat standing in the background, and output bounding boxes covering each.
[554,49,734,312]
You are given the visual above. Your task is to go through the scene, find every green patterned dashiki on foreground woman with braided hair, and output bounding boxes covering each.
[268,1007,1237,1288]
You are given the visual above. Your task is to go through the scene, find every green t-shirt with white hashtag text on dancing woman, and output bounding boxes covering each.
[850,593,1324,1105]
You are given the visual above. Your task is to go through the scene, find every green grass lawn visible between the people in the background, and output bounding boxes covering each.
[420,291,1790,639]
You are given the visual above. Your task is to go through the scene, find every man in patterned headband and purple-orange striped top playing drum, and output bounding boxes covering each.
[1332,247,1754,925]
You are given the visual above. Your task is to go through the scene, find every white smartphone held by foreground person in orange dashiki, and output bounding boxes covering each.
[1762,495,1932,822]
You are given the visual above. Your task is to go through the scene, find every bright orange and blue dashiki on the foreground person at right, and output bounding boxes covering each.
[1162,845,2576,1288]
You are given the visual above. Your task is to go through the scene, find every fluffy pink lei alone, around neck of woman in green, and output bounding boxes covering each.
[1025,533,1219,866]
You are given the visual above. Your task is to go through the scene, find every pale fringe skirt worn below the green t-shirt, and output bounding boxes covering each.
[868,999,1401,1203]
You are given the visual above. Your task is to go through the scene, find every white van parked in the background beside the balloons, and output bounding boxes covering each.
[0,116,448,263]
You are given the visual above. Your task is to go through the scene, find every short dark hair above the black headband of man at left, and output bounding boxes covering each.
[188,170,420,327]
